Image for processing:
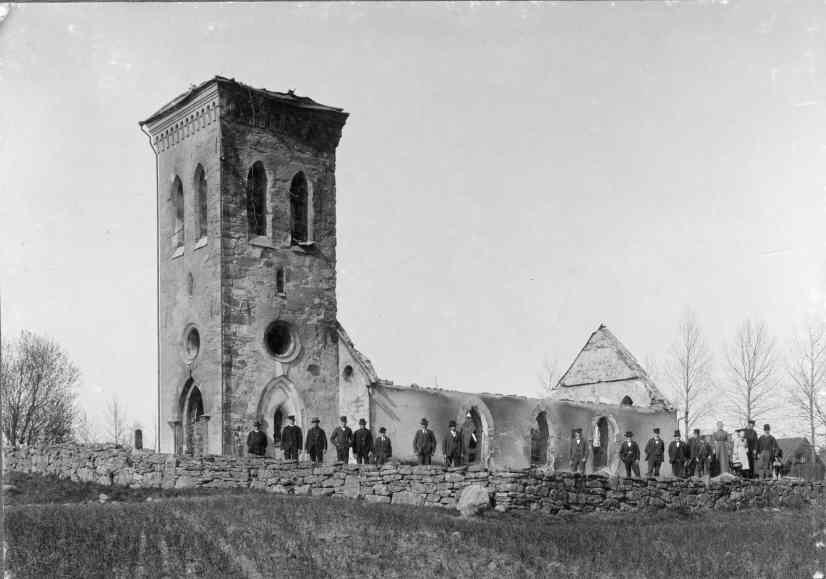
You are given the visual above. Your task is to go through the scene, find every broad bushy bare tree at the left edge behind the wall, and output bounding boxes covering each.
[0,331,80,445]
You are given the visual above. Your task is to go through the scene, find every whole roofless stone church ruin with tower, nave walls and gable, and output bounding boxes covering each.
[140,76,676,471]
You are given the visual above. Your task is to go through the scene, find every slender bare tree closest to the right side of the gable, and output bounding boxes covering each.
[665,311,712,434]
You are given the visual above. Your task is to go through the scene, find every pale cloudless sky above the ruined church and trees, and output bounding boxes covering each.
[0,0,826,444]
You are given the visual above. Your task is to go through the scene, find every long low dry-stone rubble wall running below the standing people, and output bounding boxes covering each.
[3,444,826,514]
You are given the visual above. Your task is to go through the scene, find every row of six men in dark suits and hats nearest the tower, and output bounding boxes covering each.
[247,415,393,465]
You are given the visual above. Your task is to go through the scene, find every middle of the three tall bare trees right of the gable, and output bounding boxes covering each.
[726,320,777,424]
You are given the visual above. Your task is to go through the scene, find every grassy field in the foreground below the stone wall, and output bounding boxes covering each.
[6,475,826,578]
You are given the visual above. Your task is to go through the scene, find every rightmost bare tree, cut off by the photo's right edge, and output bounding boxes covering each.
[787,320,826,465]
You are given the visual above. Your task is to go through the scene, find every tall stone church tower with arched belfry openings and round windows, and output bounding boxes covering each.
[140,77,347,454]
